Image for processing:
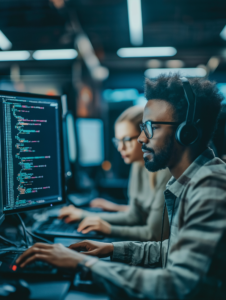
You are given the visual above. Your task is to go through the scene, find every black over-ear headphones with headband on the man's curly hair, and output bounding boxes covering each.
[175,77,202,146]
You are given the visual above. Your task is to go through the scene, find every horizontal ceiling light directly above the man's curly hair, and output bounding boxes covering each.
[144,68,206,78]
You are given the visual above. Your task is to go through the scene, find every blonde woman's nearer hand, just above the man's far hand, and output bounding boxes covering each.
[77,216,111,234]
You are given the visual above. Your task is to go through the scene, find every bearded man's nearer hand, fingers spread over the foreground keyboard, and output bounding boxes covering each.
[16,243,84,269]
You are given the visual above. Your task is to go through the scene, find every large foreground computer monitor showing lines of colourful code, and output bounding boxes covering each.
[0,91,65,214]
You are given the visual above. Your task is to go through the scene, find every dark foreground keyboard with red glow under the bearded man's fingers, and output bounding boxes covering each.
[0,251,58,275]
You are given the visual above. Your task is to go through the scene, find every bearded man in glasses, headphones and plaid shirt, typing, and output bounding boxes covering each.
[17,74,226,299]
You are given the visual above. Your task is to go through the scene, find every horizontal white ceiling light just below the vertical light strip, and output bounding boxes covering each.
[117,47,177,57]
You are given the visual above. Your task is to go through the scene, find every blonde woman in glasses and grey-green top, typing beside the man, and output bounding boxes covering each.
[59,106,170,241]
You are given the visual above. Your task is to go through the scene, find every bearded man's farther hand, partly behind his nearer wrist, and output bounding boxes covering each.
[69,241,114,257]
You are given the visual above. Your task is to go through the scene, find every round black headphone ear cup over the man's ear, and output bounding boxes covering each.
[175,122,201,146]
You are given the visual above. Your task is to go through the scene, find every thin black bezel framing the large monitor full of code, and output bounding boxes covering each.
[0,90,66,215]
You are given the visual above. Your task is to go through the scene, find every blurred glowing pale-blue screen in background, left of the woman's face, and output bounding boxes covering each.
[76,119,104,167]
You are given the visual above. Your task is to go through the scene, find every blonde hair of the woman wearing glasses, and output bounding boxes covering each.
[115,105,157,188]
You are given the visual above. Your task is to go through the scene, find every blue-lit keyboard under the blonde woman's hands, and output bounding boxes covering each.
[33,217,104,239]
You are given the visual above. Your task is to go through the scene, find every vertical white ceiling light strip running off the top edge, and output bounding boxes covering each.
[127,0,143,46]
